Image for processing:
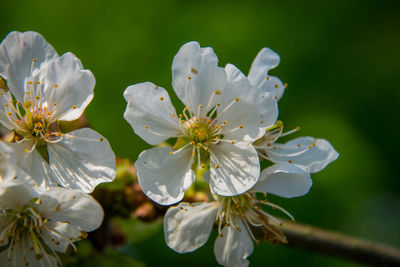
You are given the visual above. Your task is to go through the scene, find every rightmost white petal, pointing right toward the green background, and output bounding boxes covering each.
[266,137,339,173]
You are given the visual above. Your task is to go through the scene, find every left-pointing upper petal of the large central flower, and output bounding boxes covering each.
[124,82,181,145]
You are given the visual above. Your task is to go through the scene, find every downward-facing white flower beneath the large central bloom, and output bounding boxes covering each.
[164,163,312,266]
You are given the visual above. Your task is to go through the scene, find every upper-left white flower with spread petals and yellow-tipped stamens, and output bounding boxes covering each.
[0,32,115,192]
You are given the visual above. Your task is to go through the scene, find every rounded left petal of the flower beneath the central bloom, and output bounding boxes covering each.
[164,203,218,253]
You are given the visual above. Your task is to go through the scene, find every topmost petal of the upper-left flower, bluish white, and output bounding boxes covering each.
[0,32,57,102]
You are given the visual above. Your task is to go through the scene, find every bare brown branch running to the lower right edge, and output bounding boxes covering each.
[256,220,400,266]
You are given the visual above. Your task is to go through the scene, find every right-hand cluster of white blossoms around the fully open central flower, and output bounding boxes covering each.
[124,42,338,266]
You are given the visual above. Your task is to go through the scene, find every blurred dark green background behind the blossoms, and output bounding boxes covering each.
[0,0,400,266]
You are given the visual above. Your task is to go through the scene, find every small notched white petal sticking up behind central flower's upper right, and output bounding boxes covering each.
[248,48,285,100]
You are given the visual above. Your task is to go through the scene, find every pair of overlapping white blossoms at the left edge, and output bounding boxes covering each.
[0,32,116,266]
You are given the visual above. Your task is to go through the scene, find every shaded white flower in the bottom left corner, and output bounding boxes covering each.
[0,179,103,266]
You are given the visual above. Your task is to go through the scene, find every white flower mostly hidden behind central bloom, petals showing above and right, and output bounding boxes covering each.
[222,48,339,173]
